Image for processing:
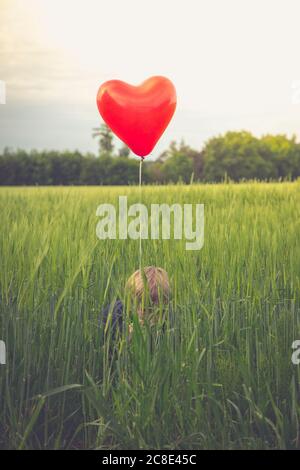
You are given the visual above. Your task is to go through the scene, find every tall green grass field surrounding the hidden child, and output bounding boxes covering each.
[0,182,300,449]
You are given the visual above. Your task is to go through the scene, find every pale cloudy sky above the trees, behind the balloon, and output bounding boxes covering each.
[0,0,300,158]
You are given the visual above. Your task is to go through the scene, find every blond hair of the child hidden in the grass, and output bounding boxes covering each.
[125,266,170,305]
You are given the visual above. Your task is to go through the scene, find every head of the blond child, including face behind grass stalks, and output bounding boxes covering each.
[126,266,170,320]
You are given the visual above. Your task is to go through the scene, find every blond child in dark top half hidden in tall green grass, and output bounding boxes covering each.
[102,266,170,336]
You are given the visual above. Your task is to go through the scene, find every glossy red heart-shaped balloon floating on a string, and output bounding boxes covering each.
[97,76,176,158]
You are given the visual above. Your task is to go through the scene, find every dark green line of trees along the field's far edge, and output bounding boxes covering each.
[0,125,300,186]
